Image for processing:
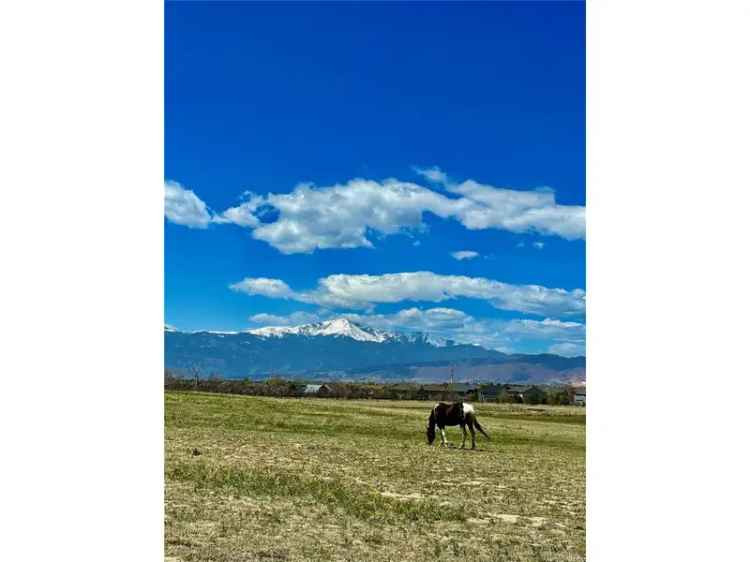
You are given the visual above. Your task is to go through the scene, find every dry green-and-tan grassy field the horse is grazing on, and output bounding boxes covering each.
[165,392,586,562]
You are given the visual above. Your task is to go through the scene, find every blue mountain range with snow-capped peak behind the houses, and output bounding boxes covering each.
[164,318,586,383]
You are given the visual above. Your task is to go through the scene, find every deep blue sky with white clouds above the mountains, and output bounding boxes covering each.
[165,2,585,355]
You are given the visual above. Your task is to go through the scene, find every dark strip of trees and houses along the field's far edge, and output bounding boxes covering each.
[164,370,575,405]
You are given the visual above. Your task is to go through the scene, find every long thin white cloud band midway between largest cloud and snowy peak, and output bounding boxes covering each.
[230,271,585,316]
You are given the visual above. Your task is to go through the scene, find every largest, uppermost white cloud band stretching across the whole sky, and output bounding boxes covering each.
[167,167,585,254]
